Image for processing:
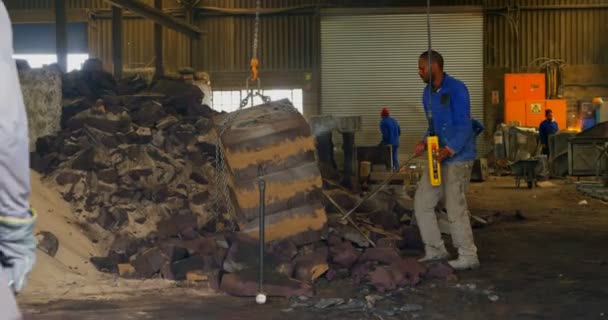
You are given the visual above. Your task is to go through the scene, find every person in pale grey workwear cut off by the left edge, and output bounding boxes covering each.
[0,1,36,320]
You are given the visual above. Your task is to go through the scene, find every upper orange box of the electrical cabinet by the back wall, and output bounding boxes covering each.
[505,73,546,101]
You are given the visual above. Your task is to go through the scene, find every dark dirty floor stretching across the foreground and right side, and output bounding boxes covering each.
[23,177,608,320]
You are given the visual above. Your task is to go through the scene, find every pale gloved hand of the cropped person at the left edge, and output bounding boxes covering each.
[0,214,36,293]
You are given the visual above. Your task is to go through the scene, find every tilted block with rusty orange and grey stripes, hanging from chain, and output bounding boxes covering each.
[214,99,327,245]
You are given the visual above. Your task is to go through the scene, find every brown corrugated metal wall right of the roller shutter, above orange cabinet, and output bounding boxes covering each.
[486,0,608,70]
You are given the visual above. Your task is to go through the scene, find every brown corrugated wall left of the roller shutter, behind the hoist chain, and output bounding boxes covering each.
[194,0,320,88]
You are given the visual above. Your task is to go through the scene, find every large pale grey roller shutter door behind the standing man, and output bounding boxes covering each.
[321,10,484,155]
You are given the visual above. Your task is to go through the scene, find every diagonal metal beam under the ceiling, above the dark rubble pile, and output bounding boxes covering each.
[105,0,202,38]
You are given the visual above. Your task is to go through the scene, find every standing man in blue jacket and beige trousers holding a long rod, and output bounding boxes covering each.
[414,51,480,270]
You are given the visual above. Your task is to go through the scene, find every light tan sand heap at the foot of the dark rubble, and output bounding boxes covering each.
[19,172,172,303]
